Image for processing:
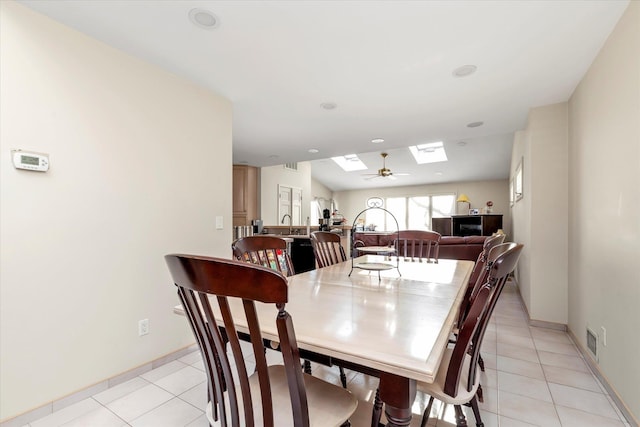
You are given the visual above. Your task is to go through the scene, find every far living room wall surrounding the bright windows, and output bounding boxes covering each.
[333,180,511,239]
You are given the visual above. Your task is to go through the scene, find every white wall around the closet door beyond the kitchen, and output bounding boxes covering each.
[260,162,311,227]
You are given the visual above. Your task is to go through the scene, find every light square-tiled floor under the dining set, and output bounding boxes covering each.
[18,284,629,427]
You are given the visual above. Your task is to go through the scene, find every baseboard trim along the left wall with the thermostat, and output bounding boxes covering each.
[0,344,198,427]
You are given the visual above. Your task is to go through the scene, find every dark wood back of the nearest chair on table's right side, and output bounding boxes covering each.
[444,243,523,396]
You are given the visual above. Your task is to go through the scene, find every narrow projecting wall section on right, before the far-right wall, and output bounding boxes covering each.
[511,103,568,325]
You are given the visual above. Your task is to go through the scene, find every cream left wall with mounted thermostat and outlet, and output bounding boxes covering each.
[0,1,232,419]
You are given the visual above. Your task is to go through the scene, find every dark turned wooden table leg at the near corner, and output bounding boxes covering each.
[380,372,416,427]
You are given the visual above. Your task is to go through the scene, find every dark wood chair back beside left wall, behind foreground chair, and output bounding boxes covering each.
[231,236,295,276]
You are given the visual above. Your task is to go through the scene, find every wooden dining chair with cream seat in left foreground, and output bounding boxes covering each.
[165,255,358,427]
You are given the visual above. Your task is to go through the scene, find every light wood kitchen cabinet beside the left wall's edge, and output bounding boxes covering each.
[233,165,259,227]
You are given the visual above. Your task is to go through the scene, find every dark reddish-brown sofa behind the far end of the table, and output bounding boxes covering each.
[353,232,487,261]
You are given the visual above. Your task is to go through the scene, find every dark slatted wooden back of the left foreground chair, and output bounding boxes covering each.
[165,255,309,427]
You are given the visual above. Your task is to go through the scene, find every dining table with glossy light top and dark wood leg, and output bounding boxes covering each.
[175,255,474,427]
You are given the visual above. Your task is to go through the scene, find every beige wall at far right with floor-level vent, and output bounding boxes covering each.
[569,1,640,420]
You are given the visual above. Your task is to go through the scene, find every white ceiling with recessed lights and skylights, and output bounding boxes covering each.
[20,0,628,191]
